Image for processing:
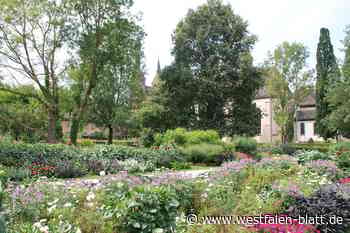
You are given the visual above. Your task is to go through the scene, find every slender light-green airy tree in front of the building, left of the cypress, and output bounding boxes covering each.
[266,42,312,143]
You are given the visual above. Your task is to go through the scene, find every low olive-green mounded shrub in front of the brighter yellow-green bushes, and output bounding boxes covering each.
[183,144,225,165]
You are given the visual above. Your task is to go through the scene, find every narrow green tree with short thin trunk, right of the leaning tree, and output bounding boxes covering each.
[90,21,144,144]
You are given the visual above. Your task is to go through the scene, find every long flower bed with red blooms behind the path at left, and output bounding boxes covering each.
[0,143,184,178]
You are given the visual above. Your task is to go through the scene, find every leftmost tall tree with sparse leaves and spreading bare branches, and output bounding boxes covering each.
[0,0,68,143]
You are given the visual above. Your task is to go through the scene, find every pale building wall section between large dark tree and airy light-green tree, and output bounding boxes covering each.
[254,98,279,143]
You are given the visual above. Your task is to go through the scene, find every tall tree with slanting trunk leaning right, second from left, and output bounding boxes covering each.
[68,0,132,144]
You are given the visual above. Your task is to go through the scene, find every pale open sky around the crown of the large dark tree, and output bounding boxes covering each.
[134,0,350,85]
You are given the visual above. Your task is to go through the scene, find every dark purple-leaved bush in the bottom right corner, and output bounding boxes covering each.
[289,184,350,233]
